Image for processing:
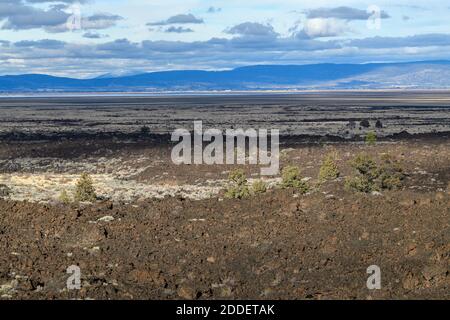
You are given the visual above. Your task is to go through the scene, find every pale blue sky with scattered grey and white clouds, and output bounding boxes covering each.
[0,0,450,78]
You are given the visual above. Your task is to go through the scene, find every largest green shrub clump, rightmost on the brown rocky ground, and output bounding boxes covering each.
[345,154,405,193]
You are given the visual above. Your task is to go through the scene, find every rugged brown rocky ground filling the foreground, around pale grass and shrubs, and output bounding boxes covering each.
[0,137,450,299]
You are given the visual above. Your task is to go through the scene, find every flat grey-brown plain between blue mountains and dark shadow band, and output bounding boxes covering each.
[0,91,450,137]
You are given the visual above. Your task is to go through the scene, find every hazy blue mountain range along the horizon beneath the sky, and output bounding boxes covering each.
[0,61,450,93]
